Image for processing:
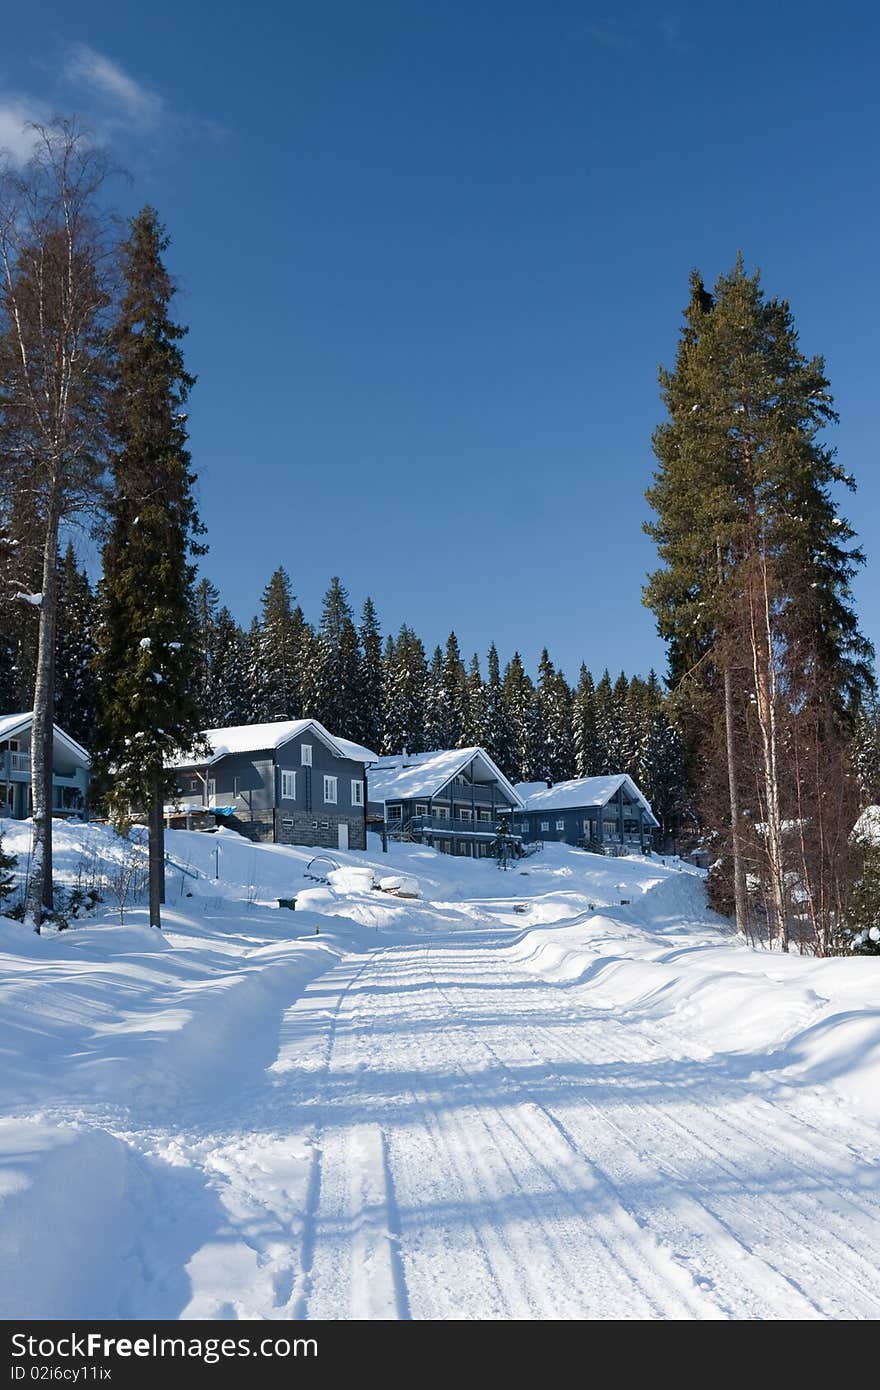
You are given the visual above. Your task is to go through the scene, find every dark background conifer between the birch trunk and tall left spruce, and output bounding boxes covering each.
[54,543,97,748]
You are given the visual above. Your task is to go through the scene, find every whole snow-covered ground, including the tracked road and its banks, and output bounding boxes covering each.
[0,821,880,1319]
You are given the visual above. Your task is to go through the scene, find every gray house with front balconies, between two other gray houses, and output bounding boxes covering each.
[370,748,523,859]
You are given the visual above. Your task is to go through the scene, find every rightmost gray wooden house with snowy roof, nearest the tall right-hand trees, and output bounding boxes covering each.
[513,773,660,853]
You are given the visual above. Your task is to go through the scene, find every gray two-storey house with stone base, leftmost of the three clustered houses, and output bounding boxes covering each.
[165,719,377,849]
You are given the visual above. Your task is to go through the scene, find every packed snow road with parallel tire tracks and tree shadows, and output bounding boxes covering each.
[6,915,880,1319]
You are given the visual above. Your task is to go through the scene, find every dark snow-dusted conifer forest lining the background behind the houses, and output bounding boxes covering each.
[0,546,684,834]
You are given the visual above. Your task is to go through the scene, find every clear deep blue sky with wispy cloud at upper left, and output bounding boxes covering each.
[0,0,880,686]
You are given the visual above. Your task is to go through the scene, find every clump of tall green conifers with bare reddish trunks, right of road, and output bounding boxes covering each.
[645,259,872,949]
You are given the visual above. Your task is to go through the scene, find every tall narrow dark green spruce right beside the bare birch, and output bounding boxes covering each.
[97,207,203,927]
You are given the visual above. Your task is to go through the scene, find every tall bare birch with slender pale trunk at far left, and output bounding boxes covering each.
[0,120,114,930]
